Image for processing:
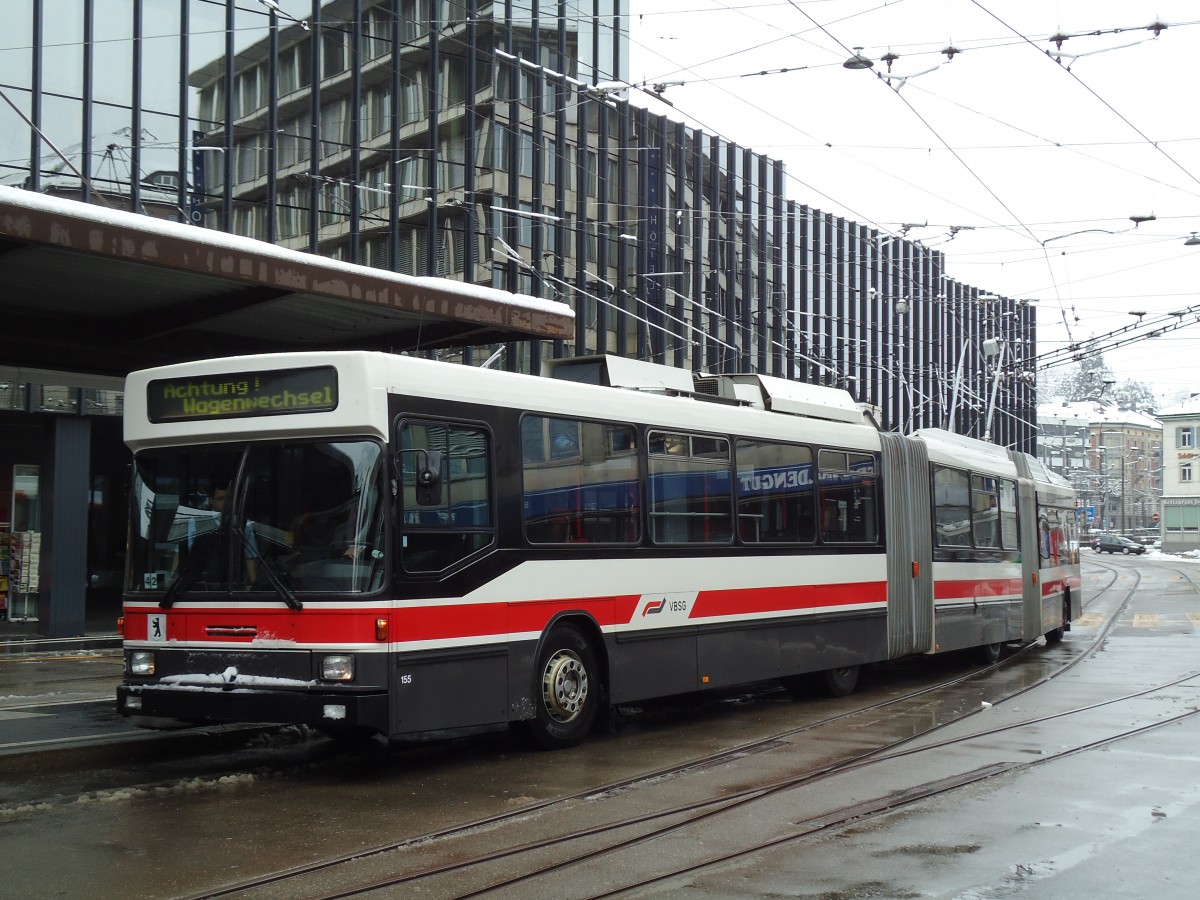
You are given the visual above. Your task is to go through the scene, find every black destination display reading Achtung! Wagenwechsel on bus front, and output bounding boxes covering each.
[146,366,337,422]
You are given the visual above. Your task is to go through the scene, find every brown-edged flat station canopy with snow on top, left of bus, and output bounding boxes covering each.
[0,187,575,377]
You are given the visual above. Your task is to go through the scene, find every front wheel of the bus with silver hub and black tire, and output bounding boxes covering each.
[528,624,601,750]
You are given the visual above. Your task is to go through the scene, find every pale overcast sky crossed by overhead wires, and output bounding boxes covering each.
[630,0,1200,402]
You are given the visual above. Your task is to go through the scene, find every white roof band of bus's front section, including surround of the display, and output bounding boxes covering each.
[125,350,880,451]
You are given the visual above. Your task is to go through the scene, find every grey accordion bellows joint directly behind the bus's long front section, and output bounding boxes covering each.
[880,433,934,659]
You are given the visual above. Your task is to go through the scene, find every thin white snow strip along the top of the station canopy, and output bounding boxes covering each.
[0,185,575,319]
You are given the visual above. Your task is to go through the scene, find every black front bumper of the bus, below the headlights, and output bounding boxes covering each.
[116,683,388,733]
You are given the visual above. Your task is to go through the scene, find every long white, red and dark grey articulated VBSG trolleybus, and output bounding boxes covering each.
[119,352,1080,748]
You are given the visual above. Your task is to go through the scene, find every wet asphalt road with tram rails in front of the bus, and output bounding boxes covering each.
[0,554,1200,900]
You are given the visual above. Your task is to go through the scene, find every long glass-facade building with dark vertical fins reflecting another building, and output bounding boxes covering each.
[0,0,1036,451]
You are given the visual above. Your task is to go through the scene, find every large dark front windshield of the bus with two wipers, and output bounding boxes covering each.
[126,440,386,605]
